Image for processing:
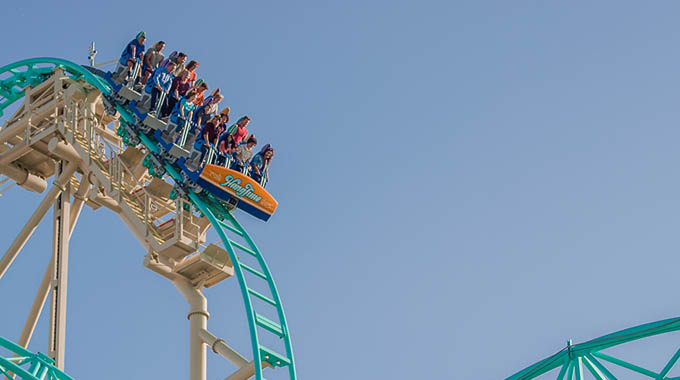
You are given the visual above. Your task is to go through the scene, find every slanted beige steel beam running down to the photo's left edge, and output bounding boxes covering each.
[0,163,77,279]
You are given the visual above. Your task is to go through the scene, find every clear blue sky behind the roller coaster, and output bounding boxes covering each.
[0,0,680,380]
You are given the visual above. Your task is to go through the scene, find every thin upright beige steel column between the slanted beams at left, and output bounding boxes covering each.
[48,163,71,370]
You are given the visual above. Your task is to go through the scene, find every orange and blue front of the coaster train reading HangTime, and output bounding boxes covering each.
[195,164,279,222]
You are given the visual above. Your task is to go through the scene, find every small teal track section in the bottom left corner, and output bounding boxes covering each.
[0,337,73,380]
